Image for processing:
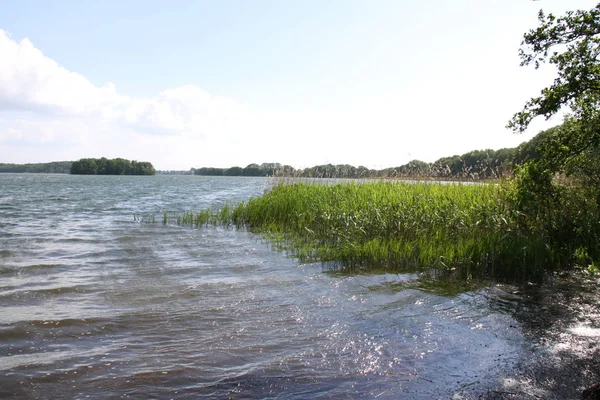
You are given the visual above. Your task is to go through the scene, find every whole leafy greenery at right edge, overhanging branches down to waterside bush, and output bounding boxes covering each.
[508,4,600,270]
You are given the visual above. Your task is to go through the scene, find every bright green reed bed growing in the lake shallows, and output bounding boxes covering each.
[170,182,562,277]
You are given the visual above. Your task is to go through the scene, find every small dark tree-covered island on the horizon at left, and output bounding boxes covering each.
[70,157,156,175]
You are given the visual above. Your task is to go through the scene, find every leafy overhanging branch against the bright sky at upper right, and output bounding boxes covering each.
[508,4,600,132]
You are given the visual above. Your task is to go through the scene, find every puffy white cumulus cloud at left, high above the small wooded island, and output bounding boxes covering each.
[0,30,245,136]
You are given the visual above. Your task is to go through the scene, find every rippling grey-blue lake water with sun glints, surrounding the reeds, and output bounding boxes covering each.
[0,174,600,399]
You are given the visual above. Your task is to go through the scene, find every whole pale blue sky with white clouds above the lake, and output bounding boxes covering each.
[0,0,596,170]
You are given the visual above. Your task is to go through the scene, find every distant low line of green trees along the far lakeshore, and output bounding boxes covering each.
[0,123,556,181]
